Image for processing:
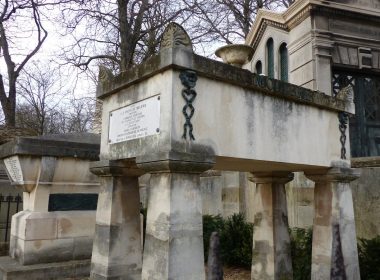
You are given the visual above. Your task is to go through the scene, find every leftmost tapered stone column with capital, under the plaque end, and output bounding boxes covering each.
[91,161,142,280]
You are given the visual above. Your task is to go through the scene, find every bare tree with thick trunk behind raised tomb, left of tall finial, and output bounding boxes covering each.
[61,0,190,71]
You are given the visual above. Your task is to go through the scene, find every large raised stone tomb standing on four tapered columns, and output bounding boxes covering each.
[91,24,360,280]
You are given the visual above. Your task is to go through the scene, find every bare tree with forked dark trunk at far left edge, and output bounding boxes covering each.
[0,0,52,126]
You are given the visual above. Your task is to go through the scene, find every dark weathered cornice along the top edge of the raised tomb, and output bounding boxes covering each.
[97,48,353,113]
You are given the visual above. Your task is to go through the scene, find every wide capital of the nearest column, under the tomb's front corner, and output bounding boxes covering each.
[136,151,215,174]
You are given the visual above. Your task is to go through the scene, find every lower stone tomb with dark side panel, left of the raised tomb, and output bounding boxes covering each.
[0,133,99,279]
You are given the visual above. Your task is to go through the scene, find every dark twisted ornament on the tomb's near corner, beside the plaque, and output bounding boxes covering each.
[179,70,198,140]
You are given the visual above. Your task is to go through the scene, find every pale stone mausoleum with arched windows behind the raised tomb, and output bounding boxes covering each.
[245,0,380,238]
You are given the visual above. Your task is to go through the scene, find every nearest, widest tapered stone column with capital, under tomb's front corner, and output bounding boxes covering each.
[137,152,214,280]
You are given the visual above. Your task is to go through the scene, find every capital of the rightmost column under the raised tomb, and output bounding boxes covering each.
[304,167,360,183]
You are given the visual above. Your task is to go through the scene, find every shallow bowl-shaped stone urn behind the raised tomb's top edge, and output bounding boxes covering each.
[215,44,253,68]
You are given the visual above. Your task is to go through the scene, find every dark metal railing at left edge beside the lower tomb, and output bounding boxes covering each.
[0,194,22,242]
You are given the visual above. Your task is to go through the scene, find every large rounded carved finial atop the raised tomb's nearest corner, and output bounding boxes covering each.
[160,22,193,51]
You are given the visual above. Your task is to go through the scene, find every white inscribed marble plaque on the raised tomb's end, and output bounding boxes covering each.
[108,95,160,144]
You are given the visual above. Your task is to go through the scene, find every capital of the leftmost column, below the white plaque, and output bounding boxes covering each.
[90,160,145,177]
